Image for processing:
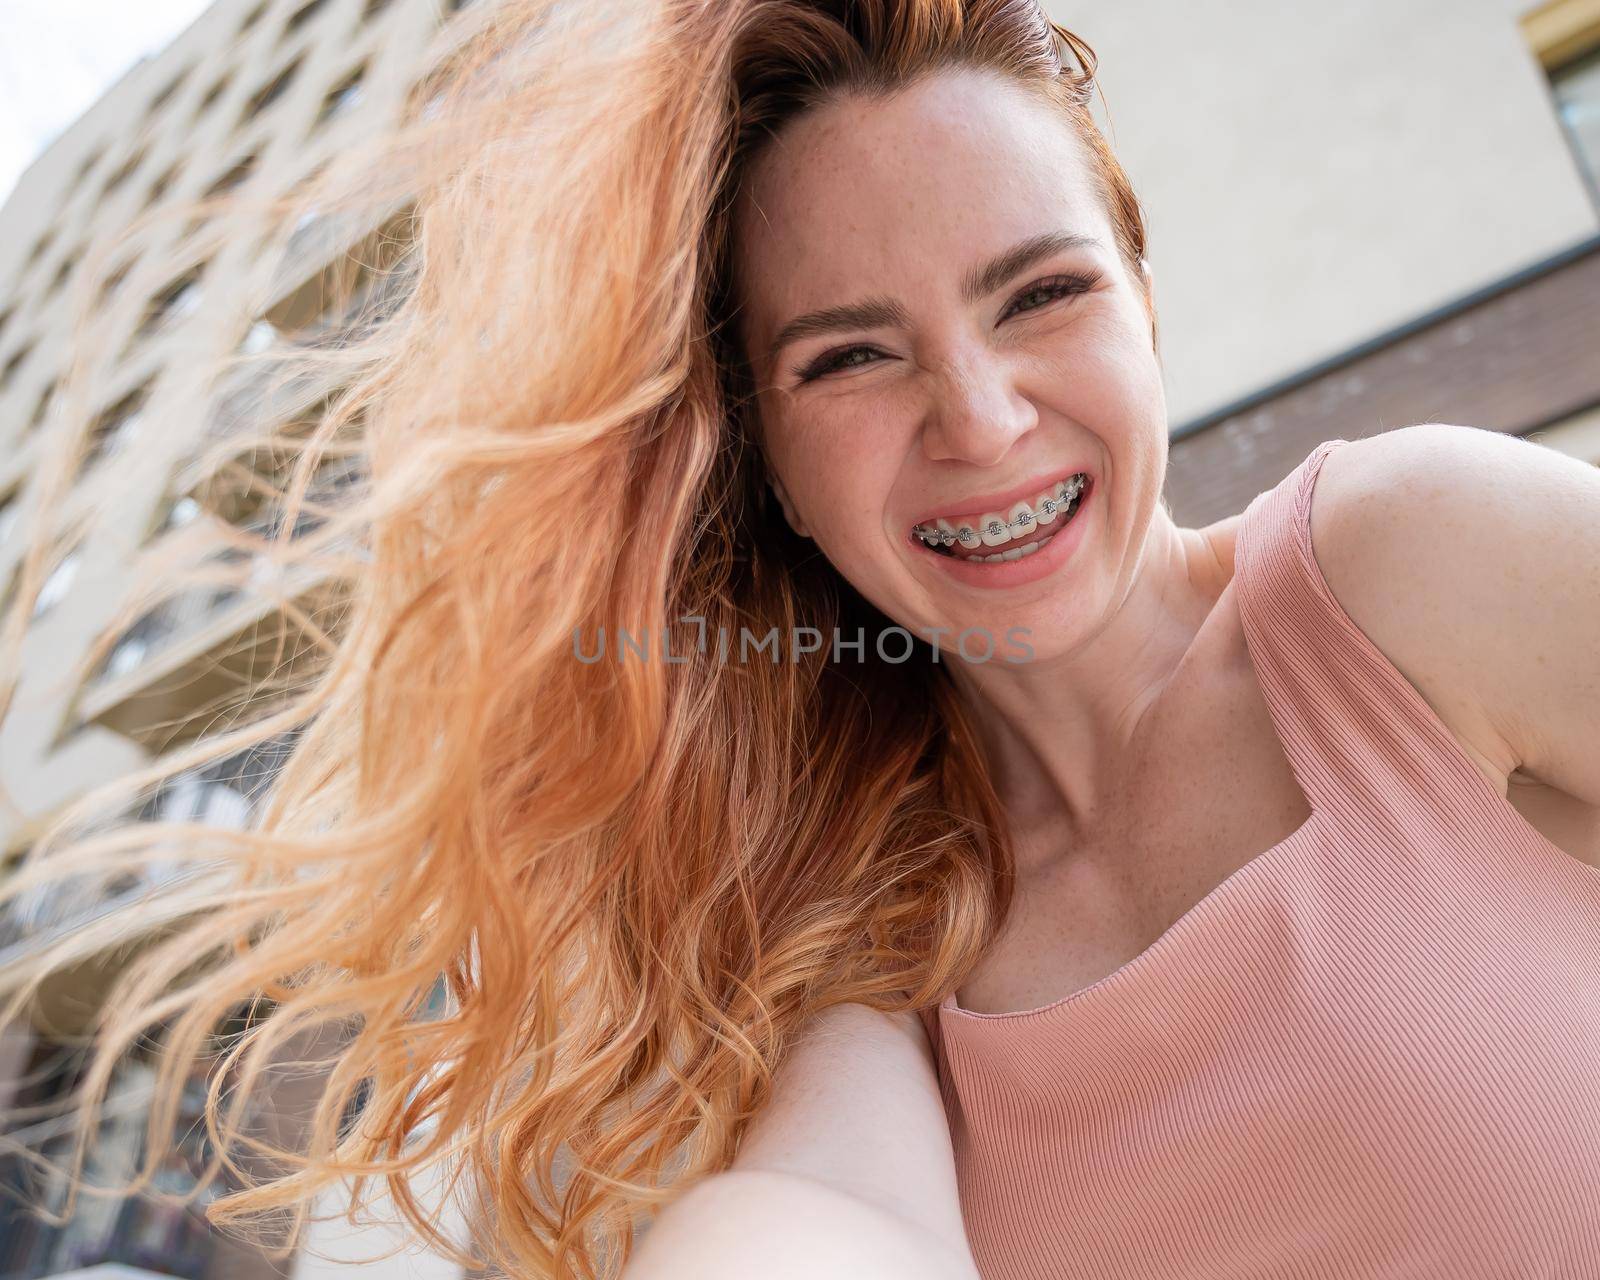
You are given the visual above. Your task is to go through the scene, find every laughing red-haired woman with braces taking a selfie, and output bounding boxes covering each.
[12,0,1600,1280]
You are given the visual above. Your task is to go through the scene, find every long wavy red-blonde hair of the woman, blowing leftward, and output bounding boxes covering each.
[0,0,1144,1278]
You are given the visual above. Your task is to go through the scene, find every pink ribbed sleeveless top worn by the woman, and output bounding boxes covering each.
[923,440,1600,1280]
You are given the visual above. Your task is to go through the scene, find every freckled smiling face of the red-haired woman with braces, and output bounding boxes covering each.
[734,69,1166,661]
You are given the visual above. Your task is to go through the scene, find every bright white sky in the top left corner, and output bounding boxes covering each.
[0,0,211,202]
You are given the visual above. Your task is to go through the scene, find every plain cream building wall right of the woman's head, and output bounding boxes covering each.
[1051,0,1600,434]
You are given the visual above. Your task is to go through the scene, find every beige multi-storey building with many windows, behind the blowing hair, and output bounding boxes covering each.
[0,0,482,1280]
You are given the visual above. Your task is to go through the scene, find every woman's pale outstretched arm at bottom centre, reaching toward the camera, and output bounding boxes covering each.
[624,1005,978,1280]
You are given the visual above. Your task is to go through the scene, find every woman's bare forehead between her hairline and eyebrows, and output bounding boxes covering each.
[733,74,1109,355]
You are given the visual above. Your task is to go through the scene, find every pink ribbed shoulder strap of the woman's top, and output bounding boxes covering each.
[1234,440,1499,826]
